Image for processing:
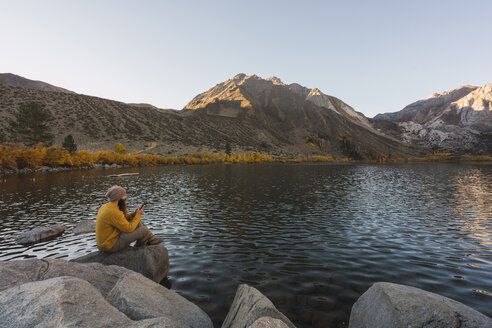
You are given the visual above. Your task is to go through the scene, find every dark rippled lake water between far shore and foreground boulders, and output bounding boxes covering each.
[0,164,492,327]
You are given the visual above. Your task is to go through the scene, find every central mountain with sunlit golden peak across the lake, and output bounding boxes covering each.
[184,74,415,158]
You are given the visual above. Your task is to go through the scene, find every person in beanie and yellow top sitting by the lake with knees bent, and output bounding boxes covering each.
[96,186,162,253]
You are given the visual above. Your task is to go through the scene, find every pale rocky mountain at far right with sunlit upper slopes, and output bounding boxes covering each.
[374,83,492,154]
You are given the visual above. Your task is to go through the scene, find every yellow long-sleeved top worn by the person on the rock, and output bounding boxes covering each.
[96,202,141,251]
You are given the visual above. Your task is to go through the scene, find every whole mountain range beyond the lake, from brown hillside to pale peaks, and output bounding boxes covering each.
[0,74,492,159]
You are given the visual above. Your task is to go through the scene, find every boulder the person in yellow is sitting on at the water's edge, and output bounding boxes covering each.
[73,245,169,282]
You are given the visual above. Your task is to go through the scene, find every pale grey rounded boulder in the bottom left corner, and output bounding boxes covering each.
[0,277,131,327]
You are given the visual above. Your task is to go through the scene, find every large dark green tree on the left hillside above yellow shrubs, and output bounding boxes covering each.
[7,101,53,146]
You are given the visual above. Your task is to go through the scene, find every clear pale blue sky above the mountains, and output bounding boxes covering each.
[0,0,492,117]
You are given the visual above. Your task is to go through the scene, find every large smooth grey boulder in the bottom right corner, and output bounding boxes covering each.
[349,282,492,328]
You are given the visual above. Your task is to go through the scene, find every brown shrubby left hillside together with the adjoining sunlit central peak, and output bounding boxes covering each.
[0,74,418,158]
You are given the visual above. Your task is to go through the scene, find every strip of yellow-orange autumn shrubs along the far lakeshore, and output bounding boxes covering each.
[0,144,492,174]
